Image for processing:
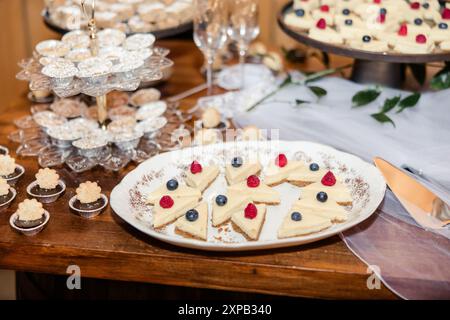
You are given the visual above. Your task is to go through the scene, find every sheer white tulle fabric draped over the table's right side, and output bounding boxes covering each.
[213,65,450,299]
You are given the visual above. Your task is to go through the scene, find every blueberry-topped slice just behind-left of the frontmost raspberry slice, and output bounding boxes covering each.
[212,194,251,227]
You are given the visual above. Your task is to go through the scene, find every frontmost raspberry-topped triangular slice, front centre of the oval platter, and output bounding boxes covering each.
[231,203,266,240]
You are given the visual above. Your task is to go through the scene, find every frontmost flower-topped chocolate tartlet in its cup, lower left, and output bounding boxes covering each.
[9,199,50,236]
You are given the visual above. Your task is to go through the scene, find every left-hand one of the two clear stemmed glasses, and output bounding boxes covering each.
[194,0,228,95]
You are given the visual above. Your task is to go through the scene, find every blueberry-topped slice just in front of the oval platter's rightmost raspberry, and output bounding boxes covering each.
[292,197,348,222]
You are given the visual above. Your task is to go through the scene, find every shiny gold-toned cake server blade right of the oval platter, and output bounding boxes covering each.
[373,158,450,229]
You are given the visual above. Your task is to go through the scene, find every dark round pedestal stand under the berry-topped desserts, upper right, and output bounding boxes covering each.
[278,2,450,87]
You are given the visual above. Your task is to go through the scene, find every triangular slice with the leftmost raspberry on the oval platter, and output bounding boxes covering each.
[153,195,198,229]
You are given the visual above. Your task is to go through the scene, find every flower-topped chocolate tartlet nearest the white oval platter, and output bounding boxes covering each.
[69,181,108,219]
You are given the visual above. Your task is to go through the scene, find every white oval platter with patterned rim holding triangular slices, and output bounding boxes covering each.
[111,140,386,251]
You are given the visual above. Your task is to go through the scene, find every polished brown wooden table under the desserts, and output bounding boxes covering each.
[0,41,395,299]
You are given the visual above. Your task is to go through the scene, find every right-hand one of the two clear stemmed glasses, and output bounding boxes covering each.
[228,0,260,87]
